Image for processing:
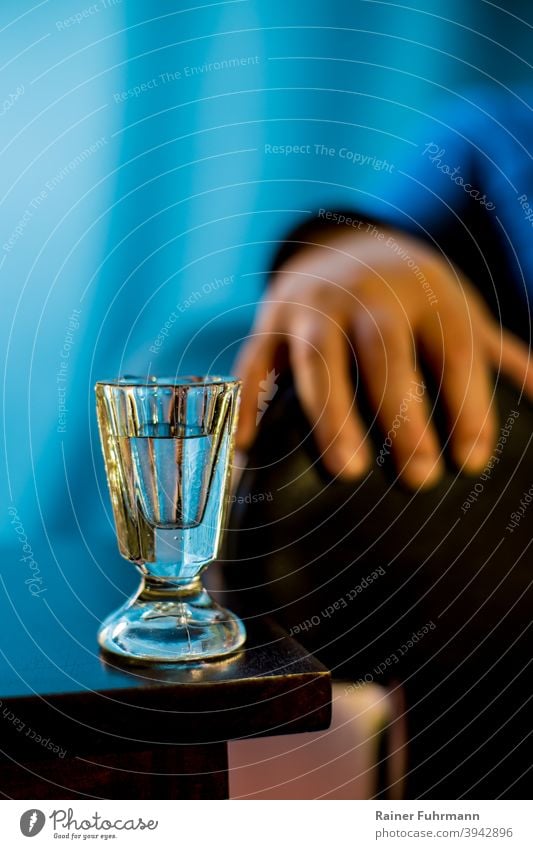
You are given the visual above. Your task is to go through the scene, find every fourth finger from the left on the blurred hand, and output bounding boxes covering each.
[420,310,496,474]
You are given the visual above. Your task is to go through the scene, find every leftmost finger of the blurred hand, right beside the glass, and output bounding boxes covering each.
[234,330,280,451]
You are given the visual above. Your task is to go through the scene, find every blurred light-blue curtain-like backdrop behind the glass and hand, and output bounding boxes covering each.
[0,0,532,544]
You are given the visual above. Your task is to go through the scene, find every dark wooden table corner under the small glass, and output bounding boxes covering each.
[0,539,331,799]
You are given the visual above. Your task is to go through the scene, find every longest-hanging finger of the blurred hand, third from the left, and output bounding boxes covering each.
[354,309,442,488]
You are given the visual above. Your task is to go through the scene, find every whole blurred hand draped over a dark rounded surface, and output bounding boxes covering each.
[235,228,533,487]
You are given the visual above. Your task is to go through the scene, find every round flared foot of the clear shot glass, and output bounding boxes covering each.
[98,579,246,663]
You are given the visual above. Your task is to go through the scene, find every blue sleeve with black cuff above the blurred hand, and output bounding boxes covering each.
[274,92,529,338]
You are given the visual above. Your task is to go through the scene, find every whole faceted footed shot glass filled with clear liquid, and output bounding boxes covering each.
[96,377,246,663]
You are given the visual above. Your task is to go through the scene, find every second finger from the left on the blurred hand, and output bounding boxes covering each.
[288,316,370,478]
